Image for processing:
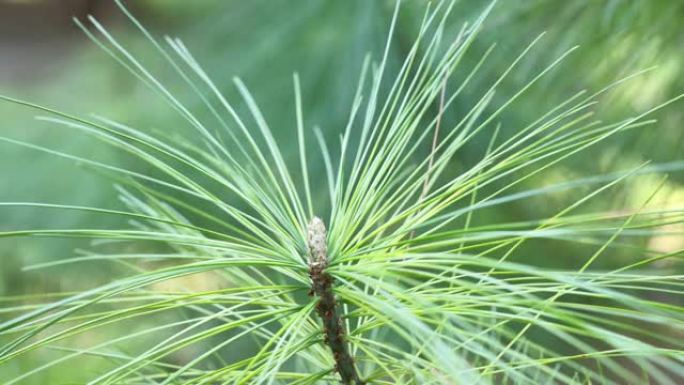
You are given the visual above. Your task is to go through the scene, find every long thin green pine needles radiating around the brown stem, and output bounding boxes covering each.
[0,2,684,384]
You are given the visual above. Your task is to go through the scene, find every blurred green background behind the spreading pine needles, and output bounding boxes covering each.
[0,0,684,384]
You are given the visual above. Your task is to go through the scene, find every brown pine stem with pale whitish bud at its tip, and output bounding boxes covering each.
[307,217,364,385]
